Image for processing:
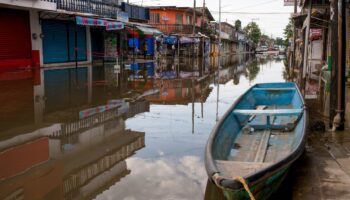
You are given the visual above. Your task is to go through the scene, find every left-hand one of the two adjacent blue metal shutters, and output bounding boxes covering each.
[42,20,68,63]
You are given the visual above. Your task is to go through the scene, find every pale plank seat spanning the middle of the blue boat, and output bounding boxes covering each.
[233,109,303,116]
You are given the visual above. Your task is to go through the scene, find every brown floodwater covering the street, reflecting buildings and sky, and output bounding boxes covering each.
[0,55,285,200]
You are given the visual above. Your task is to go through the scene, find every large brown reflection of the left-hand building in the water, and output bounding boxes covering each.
[0,66,149,199]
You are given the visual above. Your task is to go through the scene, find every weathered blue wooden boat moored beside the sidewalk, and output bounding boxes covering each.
[205,83,307,199]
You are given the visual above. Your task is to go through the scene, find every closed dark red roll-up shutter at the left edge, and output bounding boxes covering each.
[0,8,32,70]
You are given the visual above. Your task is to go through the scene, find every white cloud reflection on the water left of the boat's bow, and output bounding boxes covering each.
[96,156,207,200]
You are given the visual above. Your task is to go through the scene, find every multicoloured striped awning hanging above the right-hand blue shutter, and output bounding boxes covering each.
[75,16,124,30]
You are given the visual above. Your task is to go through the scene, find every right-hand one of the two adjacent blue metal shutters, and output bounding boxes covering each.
[68,23,87,61]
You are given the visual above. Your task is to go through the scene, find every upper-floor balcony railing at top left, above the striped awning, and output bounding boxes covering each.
[53,0,119,18]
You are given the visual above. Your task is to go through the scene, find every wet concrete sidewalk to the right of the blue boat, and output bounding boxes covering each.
[291,132,350,200]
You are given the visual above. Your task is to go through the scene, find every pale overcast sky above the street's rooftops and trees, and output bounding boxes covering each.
[129,0,294,38]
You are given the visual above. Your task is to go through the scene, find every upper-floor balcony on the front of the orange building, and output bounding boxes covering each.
[150,24,204,35]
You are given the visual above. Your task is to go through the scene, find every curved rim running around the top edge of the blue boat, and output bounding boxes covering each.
[205,82,308,190]
